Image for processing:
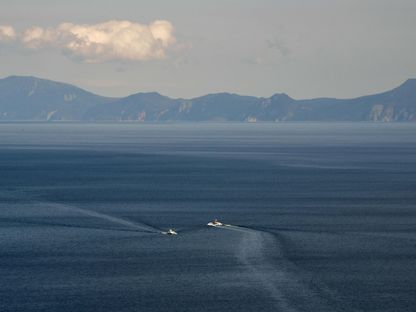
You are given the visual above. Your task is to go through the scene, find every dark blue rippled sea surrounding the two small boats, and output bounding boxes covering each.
[0,123,416,312]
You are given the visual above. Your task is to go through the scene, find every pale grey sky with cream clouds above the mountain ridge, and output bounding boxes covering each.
[0,0,416,99]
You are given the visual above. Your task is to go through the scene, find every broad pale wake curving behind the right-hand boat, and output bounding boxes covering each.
[216,225,342,312]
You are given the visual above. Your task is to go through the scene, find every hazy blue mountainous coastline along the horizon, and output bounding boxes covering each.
[0,76,416,122]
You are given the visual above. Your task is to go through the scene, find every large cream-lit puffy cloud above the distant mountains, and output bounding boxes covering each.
[19,20,175,63]
